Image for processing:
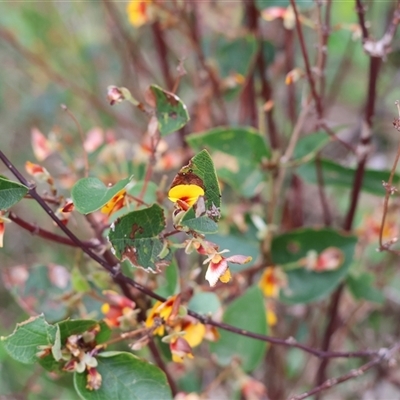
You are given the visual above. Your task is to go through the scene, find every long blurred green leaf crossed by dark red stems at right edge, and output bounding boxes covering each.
[297,160,400,196]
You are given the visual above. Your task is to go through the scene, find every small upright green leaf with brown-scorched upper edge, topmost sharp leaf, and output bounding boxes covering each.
[150,85,190,136]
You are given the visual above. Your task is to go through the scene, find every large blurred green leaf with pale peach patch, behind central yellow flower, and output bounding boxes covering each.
[186,127,270,197]
